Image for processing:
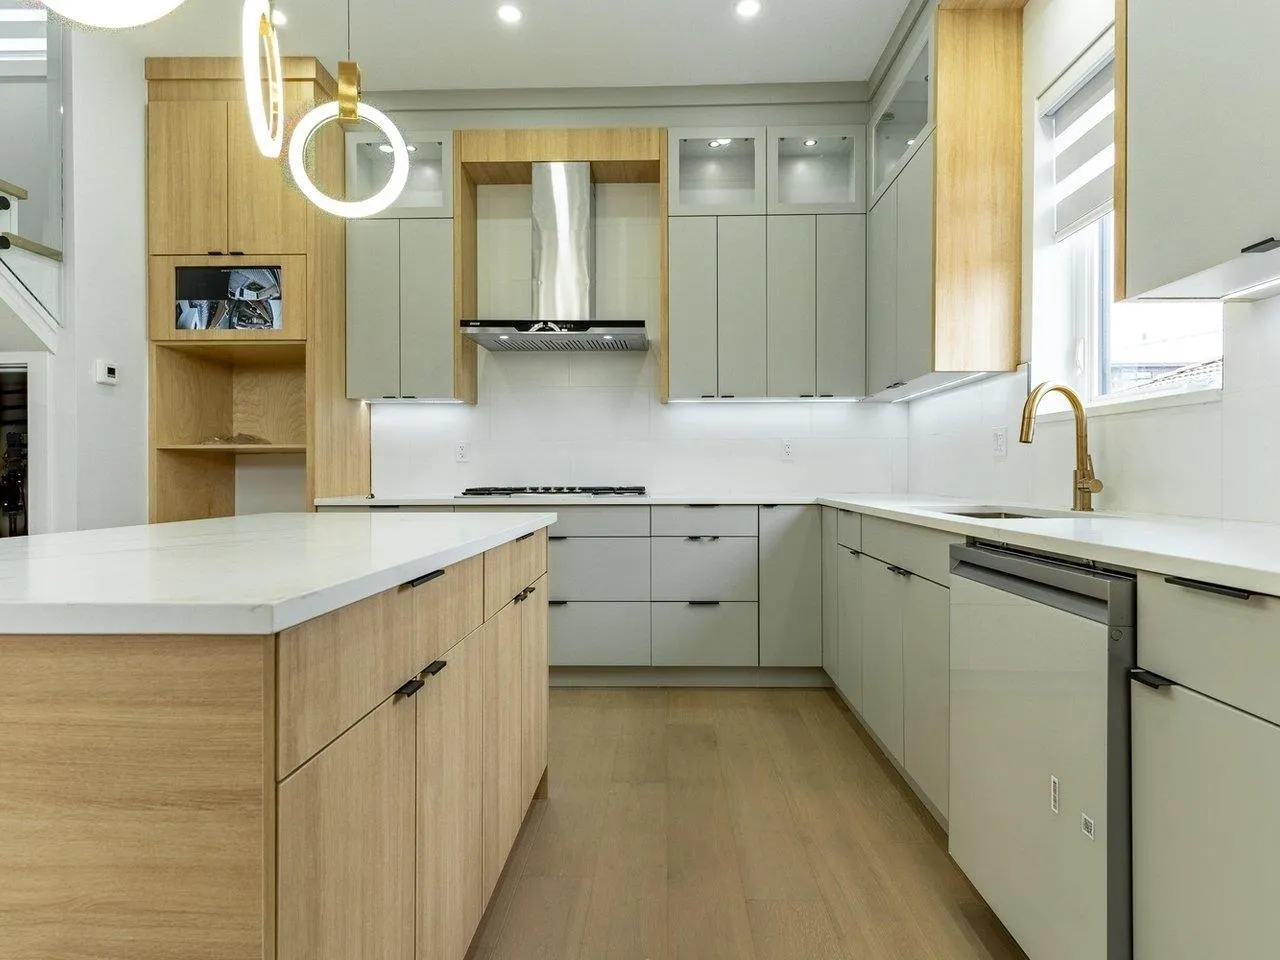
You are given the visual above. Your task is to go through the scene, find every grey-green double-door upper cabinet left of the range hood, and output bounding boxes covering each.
[347,219,454,399]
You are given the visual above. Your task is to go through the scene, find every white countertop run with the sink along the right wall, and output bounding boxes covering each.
[818,494,1280,596]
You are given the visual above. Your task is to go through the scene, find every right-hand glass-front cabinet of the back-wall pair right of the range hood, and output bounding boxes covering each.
[769,124,867,214]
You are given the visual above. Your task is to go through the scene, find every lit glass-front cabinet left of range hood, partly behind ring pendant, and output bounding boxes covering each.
[347,124,453,220]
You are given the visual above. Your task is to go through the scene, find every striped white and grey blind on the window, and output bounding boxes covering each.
[1046,59,1116,239]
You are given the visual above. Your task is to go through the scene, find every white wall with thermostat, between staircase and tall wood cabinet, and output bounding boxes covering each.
[50,29,147,530]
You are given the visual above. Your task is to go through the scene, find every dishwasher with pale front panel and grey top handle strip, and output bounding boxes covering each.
[950,541,1137,960]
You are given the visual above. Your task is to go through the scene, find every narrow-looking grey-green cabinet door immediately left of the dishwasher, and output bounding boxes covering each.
[902,576,951,819]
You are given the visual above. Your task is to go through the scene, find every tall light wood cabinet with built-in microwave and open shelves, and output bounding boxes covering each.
[146,58,370,522]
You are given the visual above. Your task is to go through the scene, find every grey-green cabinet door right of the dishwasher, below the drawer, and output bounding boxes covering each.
[1130,684,1280,960]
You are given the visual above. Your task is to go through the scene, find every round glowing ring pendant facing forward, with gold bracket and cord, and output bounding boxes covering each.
[289,0,408,220]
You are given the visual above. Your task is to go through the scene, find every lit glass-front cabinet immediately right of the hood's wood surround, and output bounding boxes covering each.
[667,127,765,216]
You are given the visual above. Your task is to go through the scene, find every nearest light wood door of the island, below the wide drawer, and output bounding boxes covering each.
[276,695,417,960]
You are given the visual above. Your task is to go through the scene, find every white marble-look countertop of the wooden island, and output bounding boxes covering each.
[0,509,556,643]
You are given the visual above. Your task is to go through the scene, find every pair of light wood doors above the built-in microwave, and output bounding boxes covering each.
[147,100,308,256]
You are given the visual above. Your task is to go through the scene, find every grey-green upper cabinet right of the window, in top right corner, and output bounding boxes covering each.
[1116,0,1280,298]
